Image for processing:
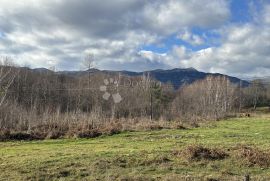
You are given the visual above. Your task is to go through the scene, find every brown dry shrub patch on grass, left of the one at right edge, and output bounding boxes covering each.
[176,145,229,161]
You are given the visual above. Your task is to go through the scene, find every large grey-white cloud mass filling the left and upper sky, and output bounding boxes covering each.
[0,0,230,70]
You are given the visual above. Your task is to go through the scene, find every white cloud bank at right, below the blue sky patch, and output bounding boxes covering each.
[141,2,270,78]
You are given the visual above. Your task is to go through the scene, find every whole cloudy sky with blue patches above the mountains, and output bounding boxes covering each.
[0,0,270,77]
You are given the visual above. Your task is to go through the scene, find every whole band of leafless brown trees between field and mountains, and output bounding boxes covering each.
[0,60,270,137]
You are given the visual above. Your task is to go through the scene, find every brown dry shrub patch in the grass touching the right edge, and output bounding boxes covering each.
[235,145,270,167]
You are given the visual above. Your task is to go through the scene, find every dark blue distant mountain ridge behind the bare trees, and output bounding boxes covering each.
[34,68,249,89]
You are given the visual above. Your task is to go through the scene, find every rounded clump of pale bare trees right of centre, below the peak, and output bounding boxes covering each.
[173,76,238,121]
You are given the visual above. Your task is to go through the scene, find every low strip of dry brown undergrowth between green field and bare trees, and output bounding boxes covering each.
[0,119,190,141]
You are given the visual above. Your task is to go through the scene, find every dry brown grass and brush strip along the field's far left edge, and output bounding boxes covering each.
[0,115,190,141]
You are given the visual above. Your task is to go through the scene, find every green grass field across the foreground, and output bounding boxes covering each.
[0,115,270,180]
